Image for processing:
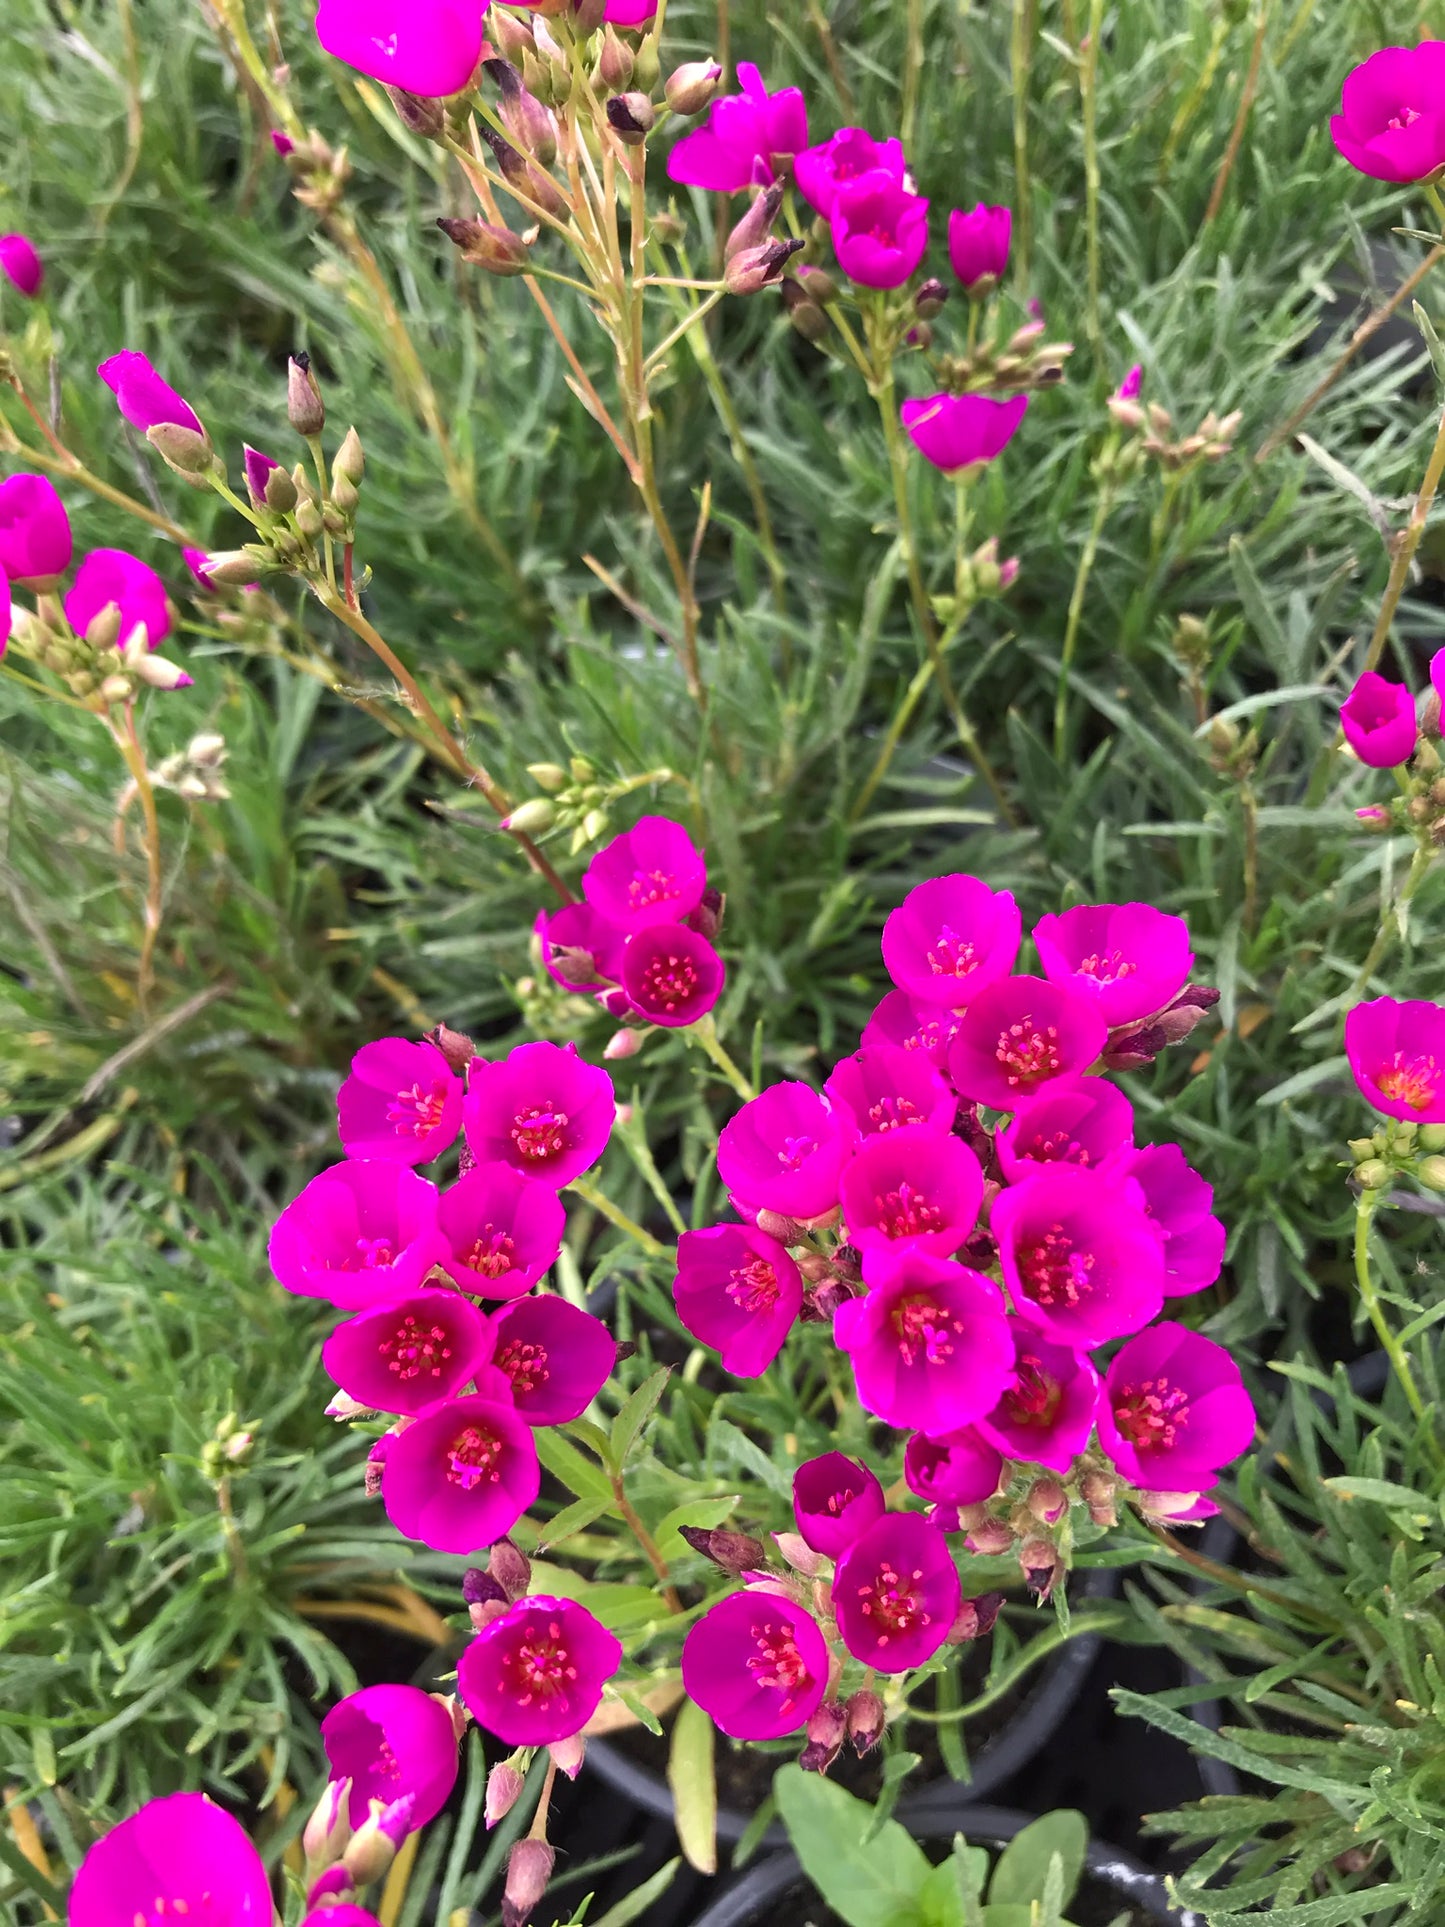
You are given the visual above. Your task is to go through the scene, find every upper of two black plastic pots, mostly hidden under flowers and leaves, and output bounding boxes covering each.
[588,1569,1119,1846]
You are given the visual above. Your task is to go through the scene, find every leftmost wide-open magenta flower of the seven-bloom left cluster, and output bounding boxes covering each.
[270,1158,443,1312]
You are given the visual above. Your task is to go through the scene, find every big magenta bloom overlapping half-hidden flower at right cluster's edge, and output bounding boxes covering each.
[988,1164,1164,1351]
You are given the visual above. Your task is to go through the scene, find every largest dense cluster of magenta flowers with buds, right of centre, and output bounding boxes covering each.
[674,875,1254,1736]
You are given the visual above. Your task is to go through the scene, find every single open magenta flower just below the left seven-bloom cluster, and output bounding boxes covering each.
[457,1594,622,1746]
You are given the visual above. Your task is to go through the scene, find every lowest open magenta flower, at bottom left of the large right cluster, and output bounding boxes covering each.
[682,1586,828,1740]
